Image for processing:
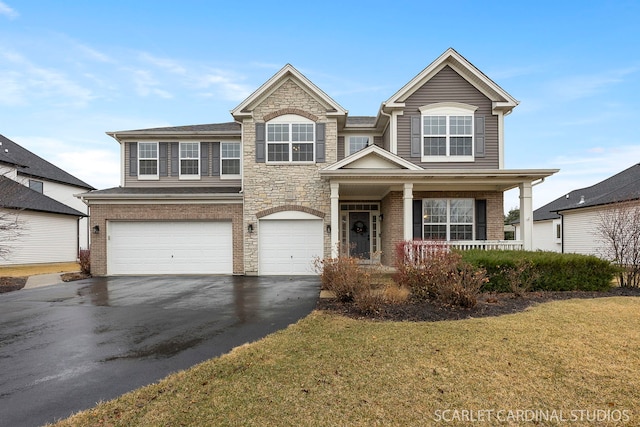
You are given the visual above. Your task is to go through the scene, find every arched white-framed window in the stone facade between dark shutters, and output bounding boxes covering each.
[267,115,315,162]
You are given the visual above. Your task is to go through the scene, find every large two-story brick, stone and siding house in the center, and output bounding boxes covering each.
[81,49,557,275]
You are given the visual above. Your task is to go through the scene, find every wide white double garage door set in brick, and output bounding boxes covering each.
[107,221,233,274]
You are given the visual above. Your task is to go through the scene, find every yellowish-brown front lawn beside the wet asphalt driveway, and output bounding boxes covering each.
[56,297,640,426]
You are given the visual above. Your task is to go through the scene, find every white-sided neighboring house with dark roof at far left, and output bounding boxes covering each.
[0,135,94,265]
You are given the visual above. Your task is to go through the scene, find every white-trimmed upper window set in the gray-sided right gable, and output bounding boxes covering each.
[420,103,477,162]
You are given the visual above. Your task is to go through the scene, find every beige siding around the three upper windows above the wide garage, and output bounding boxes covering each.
[124,138,242,187]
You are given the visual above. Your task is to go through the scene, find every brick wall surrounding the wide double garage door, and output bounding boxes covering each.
[91,203,244,276]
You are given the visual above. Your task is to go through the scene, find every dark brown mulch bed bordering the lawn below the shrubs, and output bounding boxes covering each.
[317,288,640,322]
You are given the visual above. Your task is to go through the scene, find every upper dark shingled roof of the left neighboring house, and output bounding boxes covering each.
[0,135,93,190]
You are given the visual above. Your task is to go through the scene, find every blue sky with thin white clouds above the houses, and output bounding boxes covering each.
[0,0,640,210]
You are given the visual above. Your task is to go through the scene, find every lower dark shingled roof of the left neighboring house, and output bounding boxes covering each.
[0,176,87,217]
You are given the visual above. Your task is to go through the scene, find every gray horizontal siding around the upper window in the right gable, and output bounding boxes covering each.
[398,66,499,169]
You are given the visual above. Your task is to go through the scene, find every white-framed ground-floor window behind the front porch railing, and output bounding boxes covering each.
[422,199,473,240]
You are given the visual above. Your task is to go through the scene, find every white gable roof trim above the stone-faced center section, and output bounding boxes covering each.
[231,64,347,117]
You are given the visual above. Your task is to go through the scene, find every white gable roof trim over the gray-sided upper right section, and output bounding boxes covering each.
[382,48,519,114]
